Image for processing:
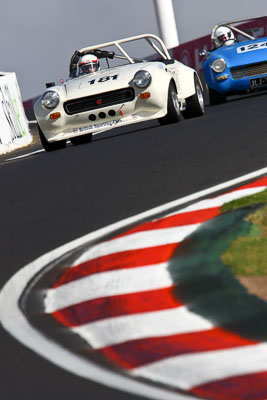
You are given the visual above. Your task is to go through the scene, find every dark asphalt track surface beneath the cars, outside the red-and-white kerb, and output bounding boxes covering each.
[0,93,267,400]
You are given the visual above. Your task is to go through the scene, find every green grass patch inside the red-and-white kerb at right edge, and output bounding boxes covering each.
[220,190,267,276]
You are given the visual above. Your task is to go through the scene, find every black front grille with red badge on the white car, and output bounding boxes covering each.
[64,88,135,115]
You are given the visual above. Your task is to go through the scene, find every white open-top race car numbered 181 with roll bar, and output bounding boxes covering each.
[34,34,204,151]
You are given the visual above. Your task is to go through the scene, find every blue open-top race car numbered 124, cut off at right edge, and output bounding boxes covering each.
[200,17,267,105]
